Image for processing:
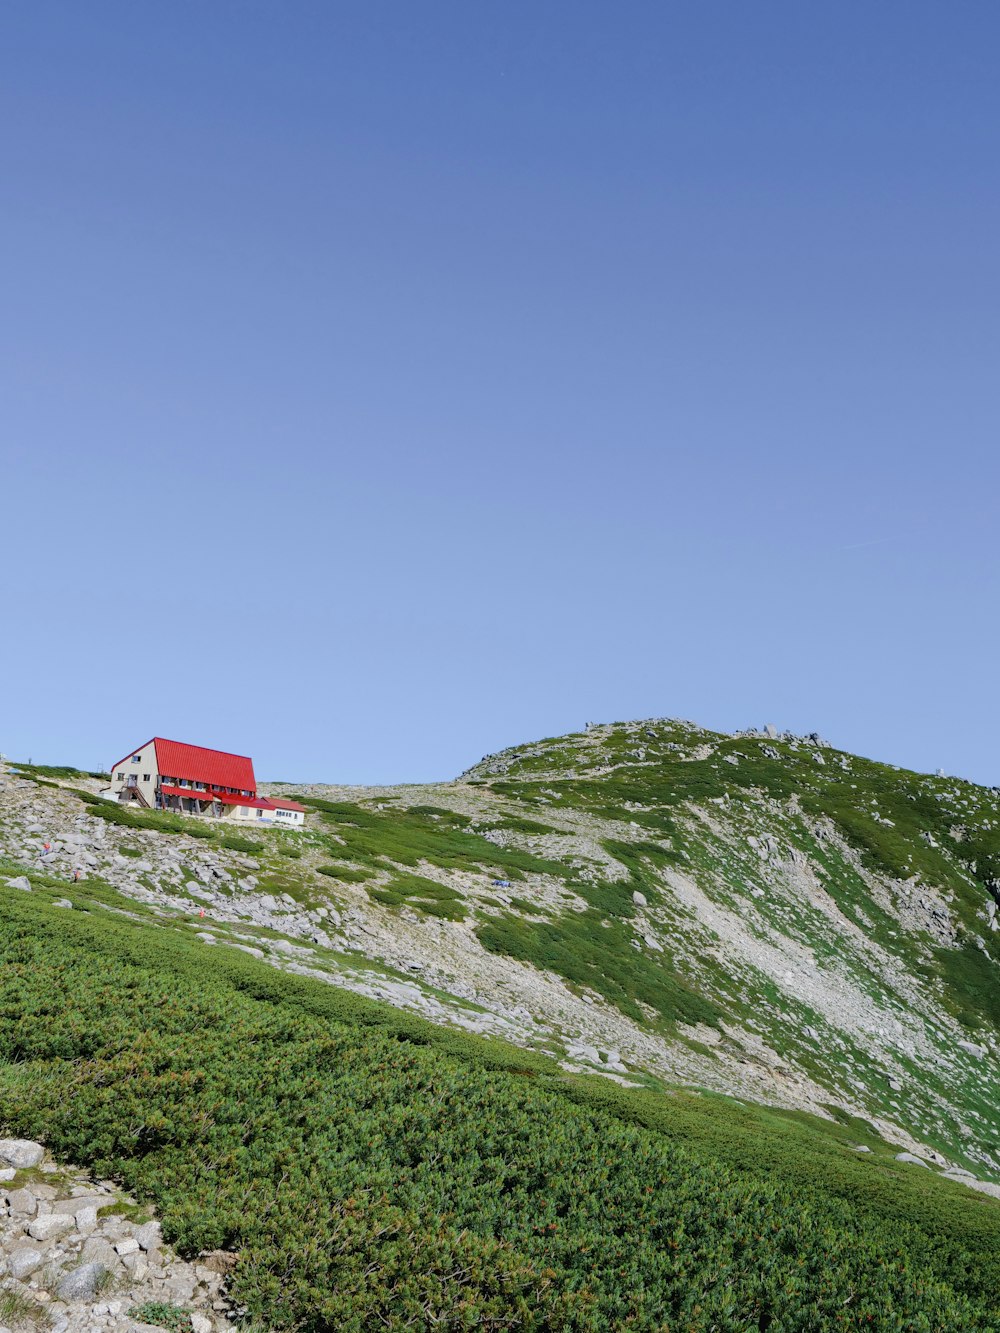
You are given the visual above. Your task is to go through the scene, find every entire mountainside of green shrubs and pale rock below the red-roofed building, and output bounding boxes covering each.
[0,720,1000,1333]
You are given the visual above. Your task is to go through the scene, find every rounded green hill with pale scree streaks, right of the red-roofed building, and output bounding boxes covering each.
[274,721,1000,1180]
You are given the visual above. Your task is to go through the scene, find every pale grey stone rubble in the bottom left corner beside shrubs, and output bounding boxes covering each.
[0,1138,235,1333]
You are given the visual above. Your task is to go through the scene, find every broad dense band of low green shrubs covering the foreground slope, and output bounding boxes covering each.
[0,889,1000,1333]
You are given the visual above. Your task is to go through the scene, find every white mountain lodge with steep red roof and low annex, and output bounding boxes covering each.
[105,736,305,828]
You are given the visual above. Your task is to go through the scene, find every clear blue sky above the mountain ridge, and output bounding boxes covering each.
[0,0,1000,782]
